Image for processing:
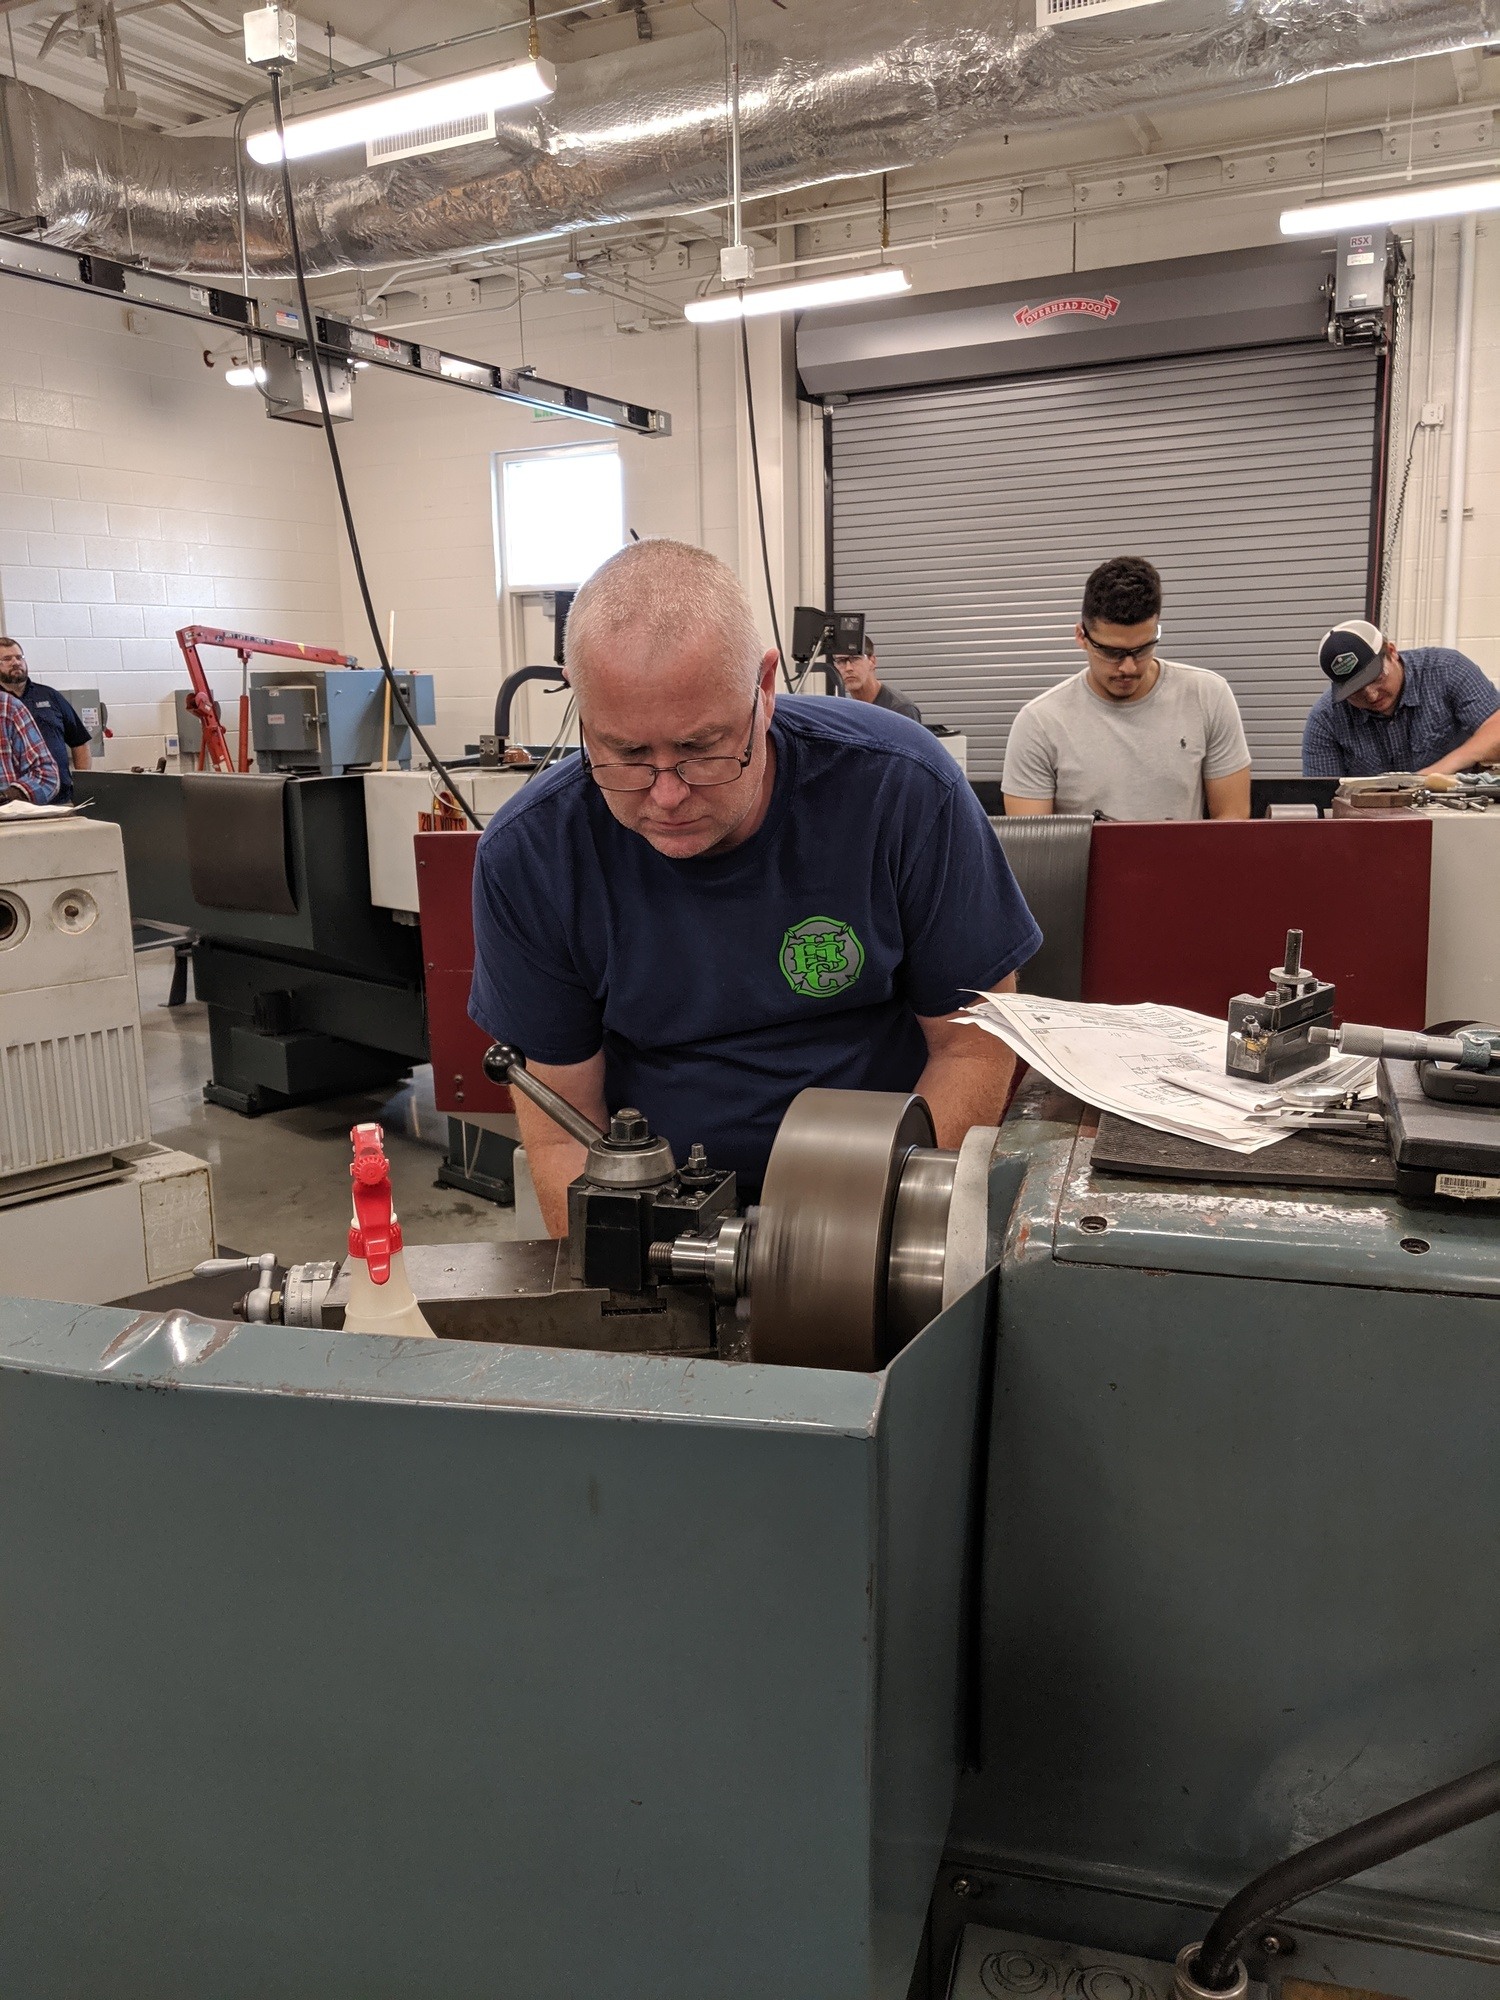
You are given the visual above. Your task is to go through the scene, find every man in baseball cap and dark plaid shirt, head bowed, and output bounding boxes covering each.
[1302,618,1500,778]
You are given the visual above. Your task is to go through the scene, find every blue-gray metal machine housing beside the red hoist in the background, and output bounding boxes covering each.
[250,666,436,778]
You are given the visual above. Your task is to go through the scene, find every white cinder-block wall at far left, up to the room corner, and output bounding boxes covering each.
[0,278,342,768]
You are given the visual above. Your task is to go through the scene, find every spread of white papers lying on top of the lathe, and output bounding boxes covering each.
[964,994,1374,1152]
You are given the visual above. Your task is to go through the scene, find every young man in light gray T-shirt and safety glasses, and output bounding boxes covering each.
[1002,556,1250,820]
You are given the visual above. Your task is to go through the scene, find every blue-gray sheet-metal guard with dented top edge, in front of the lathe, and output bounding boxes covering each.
[0,1286,988,2000]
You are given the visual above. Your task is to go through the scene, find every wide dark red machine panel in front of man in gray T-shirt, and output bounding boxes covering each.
[1084,818,1432,1028]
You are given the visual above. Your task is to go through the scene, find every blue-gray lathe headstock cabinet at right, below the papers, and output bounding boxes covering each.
[938,1092,1500,2000]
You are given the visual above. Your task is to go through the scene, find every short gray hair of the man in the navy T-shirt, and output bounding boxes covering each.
[564,540,764,694]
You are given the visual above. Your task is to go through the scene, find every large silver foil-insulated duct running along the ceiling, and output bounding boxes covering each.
[0,0,1500,276]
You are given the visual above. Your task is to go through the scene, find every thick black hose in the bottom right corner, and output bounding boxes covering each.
[1188,1764,1500,1992]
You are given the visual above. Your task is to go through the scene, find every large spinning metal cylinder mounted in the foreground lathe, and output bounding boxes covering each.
[750,1090,938,1370]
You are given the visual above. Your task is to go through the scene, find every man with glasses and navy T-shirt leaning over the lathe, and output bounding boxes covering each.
[470,542,1040,1236]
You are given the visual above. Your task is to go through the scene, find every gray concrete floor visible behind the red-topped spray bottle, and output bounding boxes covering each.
[136,952,546,1262]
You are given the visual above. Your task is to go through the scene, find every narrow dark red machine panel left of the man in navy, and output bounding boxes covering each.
[416,832,514,1118]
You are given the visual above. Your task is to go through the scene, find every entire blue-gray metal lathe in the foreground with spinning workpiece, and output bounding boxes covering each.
[0,1050,1500,2000]
